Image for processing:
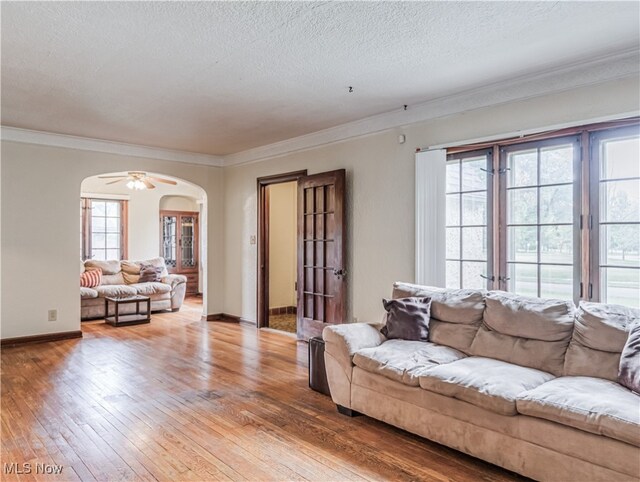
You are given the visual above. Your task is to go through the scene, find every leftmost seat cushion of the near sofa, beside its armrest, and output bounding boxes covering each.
[353,340,466,387]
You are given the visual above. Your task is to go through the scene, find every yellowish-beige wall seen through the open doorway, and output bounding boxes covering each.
[267,182,298,308]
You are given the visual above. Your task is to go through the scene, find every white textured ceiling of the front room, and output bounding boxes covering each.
[1,1,640,155]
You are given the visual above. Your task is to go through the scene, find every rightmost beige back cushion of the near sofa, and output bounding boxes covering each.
[564,301,640,381]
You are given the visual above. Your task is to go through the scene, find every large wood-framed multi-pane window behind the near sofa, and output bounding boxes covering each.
[440,119,640,307]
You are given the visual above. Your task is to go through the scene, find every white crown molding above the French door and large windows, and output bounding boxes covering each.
[224,48,640,167]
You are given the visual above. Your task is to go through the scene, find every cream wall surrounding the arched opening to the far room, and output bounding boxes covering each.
[0,147,223,338]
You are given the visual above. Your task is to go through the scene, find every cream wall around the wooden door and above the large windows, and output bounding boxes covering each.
[224,78,640,321]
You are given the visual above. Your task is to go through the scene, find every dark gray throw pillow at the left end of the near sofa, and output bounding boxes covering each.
[380,298,431,341]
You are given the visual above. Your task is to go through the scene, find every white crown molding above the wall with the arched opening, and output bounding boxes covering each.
[0,126,224,167]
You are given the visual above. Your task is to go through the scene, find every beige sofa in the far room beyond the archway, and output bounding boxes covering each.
[80,258,187,320]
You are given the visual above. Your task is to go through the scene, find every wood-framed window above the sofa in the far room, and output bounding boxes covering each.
[82,198,127,260]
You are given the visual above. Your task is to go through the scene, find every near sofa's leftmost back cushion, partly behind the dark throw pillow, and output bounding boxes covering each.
[393,282,485,354]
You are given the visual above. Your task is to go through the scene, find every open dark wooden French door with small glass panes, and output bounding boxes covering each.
[297,169,347,341]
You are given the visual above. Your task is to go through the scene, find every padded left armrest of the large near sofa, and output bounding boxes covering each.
[322,323,386,381]
